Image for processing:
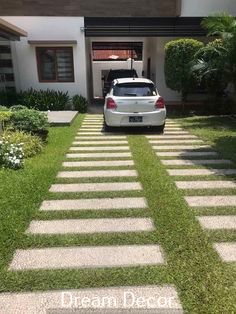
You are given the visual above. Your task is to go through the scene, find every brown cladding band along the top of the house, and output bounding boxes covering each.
[0,0,181,17]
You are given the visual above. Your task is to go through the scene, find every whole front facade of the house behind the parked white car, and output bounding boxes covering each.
[0,0,236,101]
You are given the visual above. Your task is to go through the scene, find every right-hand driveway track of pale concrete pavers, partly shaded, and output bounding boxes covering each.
[146,120,236,262]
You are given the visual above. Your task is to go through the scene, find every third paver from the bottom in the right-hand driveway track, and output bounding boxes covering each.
[185,195,236,207]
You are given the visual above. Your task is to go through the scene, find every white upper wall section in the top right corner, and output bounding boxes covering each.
[181,0,236,17]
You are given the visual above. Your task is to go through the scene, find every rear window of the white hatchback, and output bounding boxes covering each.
[113,83,157,97]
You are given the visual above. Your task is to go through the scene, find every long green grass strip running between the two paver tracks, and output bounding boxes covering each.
[130,136,234,313]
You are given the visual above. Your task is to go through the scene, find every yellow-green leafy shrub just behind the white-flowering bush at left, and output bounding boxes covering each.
[3,131,43,158]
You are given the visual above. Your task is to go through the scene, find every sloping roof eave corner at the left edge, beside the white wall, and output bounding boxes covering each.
[0,18,28,40]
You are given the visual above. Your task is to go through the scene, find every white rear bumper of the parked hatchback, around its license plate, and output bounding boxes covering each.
[104,109,166,127]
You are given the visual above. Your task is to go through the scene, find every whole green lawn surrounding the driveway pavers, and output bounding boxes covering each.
[0,116,236,313]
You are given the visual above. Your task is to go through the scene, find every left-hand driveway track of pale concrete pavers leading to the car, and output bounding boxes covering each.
[0,115,183,314]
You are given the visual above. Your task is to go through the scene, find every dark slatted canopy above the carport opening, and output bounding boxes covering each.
[84,17,206,37]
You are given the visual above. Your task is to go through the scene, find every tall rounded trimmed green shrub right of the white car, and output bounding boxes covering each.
[165,39,204,102]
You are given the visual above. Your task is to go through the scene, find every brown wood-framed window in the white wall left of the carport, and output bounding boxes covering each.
[36,47,74,82]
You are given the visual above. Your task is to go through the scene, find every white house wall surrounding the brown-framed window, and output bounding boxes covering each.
[1,16,87,97]
